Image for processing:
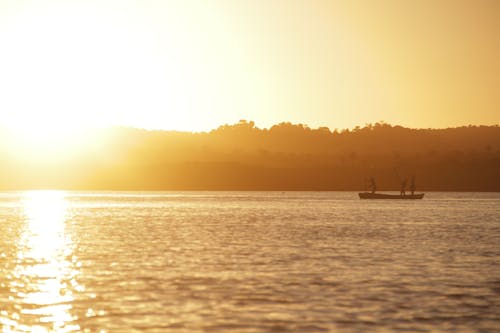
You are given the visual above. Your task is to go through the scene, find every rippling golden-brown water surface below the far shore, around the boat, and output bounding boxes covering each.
[0,191,500,332]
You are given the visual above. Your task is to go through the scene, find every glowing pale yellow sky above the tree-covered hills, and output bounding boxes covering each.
[0,0,500,132]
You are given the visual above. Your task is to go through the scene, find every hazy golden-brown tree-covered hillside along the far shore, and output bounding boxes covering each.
[0,120,500,191]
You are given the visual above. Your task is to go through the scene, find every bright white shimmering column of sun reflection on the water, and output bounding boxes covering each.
[3,191,81,332]
